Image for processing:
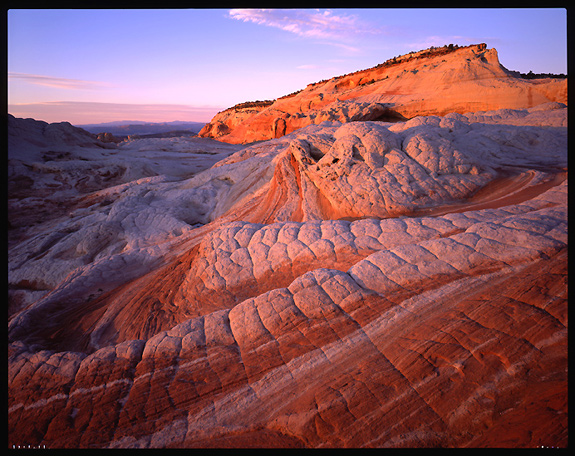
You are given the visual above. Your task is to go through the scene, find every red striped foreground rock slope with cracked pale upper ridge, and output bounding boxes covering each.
[9,209,567,447]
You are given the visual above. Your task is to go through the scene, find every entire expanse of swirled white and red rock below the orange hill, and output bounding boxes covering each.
[8,103,568,448]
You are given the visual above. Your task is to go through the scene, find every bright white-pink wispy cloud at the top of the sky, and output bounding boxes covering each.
[229,9,383,44]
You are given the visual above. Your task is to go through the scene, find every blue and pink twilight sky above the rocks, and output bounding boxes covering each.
[7,8,567,125]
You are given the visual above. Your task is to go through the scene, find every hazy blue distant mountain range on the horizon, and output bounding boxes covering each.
[76,120,206,137]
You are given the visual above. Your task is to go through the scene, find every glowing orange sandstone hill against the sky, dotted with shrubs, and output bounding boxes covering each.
[199,44,567,143]
